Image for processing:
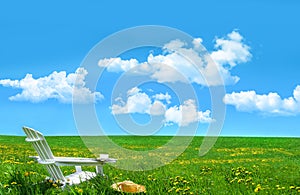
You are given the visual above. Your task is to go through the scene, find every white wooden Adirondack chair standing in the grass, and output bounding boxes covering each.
[23,127,117,185]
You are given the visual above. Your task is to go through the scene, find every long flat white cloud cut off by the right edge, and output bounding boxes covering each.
[224,85,300,115]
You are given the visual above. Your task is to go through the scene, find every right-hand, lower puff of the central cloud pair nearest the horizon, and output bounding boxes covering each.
[165,99,214,126]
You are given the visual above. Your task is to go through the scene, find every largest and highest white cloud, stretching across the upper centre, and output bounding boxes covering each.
[98,31,251,86]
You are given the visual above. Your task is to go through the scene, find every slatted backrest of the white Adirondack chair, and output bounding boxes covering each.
[23,127,65,181]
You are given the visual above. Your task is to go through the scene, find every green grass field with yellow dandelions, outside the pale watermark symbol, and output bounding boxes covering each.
[0,136,300,194]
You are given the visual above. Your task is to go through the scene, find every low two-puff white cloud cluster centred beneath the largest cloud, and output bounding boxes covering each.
[111,87,214,126]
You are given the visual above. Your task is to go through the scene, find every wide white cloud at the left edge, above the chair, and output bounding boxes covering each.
[0,68,103,104]
